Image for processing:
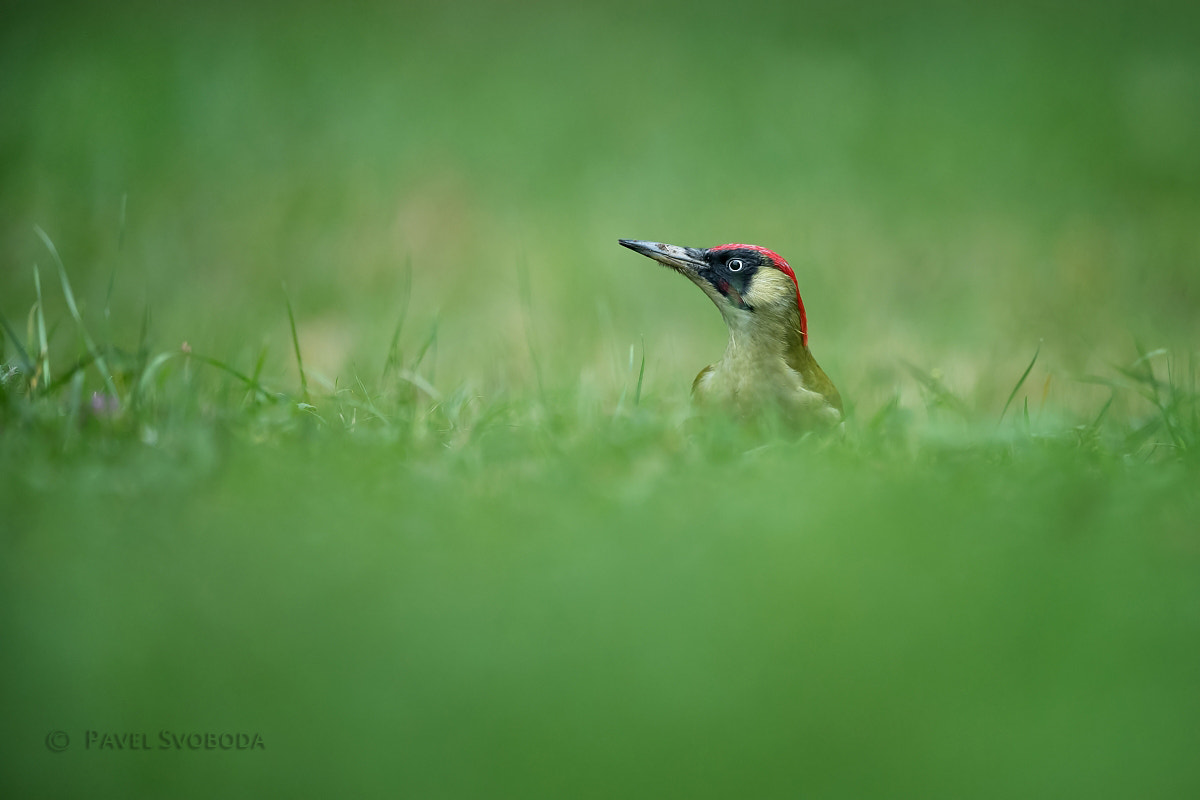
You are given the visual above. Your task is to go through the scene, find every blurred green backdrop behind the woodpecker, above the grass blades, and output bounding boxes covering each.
[0,2,1200,408]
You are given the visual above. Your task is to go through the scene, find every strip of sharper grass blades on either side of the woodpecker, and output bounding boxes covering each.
[0,241,1198,472]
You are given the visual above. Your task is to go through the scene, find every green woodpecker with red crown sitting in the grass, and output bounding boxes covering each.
[619,239,841,427]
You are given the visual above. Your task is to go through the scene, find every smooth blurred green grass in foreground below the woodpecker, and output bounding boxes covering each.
[2,426,1200,798]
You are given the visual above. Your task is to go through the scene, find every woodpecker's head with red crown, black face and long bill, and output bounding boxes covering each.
[619,239,809,347]
